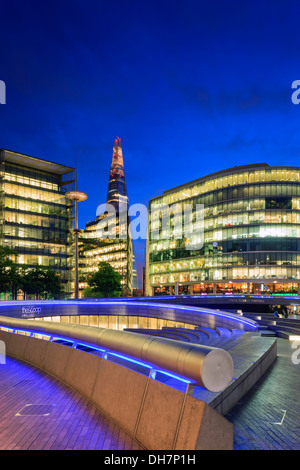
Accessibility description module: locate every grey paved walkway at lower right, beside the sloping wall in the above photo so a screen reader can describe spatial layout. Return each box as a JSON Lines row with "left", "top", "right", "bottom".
{"left": 226, "top": 338, "right": 300, "bottom": 450}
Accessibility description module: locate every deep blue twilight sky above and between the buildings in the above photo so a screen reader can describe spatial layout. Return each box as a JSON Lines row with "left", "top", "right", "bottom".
{"left": 0, "top": 0, "right": 300, "bottom": 284}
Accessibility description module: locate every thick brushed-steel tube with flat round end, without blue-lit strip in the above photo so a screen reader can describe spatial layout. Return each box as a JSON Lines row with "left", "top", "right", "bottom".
{"left": 0, "top": 316, "right": 234, "bottom": 392}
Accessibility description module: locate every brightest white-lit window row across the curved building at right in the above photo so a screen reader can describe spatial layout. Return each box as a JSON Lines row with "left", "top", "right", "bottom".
{"left": 149, "top": 224, "right": 300, "bottom": 252}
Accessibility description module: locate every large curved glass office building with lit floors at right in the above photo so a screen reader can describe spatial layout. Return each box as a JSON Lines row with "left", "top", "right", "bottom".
{"left": 146, "top": 163, "right": 300, "bottom": 295}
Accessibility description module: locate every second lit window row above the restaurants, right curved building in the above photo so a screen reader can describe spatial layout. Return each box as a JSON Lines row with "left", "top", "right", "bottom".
{"left": 150, "top": 252, "right": 300, "bottom": 274}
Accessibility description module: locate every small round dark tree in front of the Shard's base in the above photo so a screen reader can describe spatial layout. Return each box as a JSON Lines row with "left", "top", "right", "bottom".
{"left": 87, "top": 262, "right": 122, "bottom": 297}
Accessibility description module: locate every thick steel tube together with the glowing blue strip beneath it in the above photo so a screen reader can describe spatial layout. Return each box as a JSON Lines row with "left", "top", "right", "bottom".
{"left": 0, "top": 317, "right": 234, "bottom": 392}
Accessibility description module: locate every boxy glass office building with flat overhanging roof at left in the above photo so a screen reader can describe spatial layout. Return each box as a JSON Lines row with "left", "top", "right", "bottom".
{"left": 0, "top": 149, "right": 74, "bottom": 295}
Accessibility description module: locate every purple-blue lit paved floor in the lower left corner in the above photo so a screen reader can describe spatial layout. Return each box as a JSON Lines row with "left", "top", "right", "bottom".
{"left": 0, "top": 357, "right": 142, "bottom": 450}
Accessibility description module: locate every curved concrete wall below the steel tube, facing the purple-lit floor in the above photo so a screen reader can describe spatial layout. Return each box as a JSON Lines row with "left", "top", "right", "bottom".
{"left": 0, "top": 318, "right": 233, "bottom": 450}
